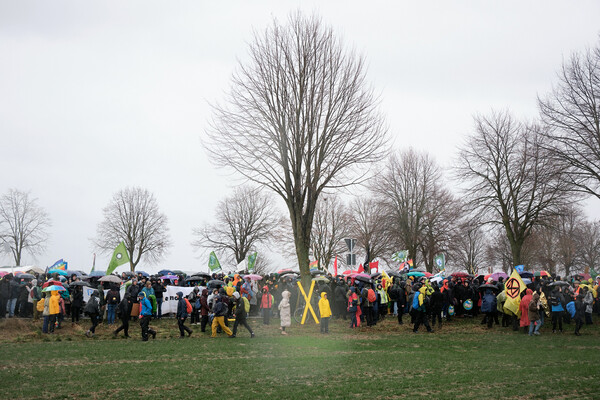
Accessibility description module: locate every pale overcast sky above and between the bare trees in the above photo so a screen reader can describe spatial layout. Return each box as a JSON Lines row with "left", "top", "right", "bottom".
{"left": 0, "top": 0, "right": 600, "bottom": 270}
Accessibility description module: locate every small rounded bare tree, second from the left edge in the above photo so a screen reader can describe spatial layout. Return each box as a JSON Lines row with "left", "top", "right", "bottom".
{"left": 95, "top": 187, "right": 171, "bottom": 271}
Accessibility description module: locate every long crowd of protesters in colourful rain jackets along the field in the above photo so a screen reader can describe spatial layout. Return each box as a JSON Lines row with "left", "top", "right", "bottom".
{"left": 0, "top": 273, "right": 600, "bottom": 341}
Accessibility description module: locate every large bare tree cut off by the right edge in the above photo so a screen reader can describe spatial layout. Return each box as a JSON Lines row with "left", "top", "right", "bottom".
{"left": 538, "top": 41, "right": 600, "bottom": 199}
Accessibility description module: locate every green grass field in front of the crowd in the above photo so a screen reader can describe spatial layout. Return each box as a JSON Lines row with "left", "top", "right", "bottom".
{"left": 0, "top": 319, "right": 600, "bottom": 400}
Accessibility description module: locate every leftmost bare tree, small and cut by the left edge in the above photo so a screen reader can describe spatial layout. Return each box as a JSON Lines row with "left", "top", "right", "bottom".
{"left": 0, "top": 189, "right": 50, "bottom": 267}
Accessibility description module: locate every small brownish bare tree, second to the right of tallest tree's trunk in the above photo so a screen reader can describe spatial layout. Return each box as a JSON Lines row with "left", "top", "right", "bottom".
{"left": 350, "top": 196, "right": 393, "bottom": 268}
